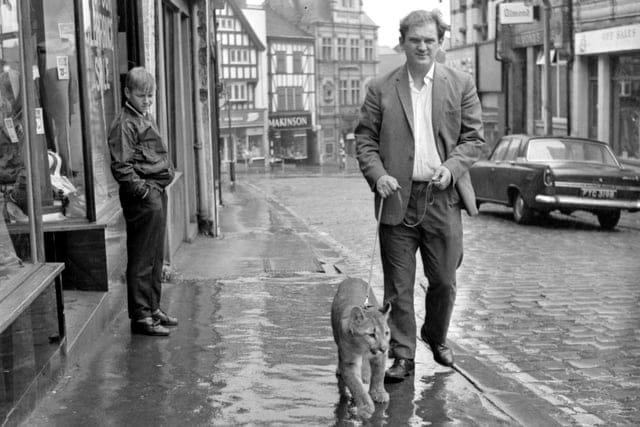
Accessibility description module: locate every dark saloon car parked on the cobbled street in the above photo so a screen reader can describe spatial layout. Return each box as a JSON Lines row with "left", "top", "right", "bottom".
{"left": 470, "top": 135, "right": 640, "bottom": 229}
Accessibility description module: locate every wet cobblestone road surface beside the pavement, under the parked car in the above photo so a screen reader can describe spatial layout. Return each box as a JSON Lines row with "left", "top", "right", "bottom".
{"left": 238, "top": 170, "right": 640, "bottom": 425}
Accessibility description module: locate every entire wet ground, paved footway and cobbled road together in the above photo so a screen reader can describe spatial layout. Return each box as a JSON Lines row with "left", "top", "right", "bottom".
{"left": 20, "top": 166, "right": 640, "bottom": 426}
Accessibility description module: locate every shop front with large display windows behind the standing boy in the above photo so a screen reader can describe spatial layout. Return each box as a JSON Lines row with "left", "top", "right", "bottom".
{"left": 0, "top": 0, "right": 217, "bottom": 423}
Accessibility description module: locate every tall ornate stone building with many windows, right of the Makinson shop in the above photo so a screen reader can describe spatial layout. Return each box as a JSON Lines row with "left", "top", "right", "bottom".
{"left": 265, "top": 0, "right": 378, "bottom": 166}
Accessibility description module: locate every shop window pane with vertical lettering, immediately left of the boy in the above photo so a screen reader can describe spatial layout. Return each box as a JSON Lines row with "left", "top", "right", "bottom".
{"left": 82, "top": 0, "right": 118, "bottom": 216}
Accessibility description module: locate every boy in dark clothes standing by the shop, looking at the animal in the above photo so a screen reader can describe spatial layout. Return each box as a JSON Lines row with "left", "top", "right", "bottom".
{"left": 109, "top": 67, "right": 178, "bottom": 336}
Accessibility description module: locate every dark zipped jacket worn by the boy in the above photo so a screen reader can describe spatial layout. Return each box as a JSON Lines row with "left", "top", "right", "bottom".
{"left": 109, "top": 103, "right": 174, "bottom": 198}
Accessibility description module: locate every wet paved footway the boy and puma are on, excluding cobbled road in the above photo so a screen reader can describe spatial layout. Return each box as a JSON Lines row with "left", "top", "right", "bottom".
{"left": 24, "top": 174, "right": 518, "bottom": 426}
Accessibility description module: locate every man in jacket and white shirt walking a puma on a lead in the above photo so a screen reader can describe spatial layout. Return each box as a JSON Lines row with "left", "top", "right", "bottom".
{"left": 355, "top": 10, "right": 485, "bottom": 381}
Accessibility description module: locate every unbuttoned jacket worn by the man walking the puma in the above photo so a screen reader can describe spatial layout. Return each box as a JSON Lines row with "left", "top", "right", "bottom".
{"left": 355, "top": 63, "right": 485, "bottom": 225}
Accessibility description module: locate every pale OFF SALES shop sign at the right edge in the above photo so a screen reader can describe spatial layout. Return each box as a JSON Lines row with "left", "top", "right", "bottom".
{"left": 575, "top": 24, "right": 640, "bottom": 55}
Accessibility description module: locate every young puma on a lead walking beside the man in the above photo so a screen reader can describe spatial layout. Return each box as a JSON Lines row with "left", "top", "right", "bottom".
{"left": 331, "top": 278, "right": 391, "bottom": 418}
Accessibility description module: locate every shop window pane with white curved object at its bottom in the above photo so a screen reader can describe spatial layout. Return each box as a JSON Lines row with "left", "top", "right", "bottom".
{"left": 31, "top": 0, "right": 87, "bottom": 222}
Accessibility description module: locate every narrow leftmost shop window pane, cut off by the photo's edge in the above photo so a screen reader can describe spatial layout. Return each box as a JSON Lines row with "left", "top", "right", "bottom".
{"left": 0, "top": 0, "right": 31, "bottom": 280}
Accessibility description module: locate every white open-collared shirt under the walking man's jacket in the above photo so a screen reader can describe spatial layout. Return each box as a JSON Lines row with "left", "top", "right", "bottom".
{"left": 409, "top": 65, "right": 442, "bottom": 181}
